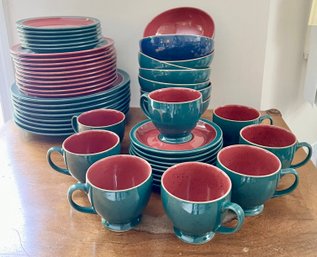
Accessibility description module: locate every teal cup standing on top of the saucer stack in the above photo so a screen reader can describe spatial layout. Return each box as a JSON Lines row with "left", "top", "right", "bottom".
{"left": 140, "top": 88, "right": 202, "bottom": 143}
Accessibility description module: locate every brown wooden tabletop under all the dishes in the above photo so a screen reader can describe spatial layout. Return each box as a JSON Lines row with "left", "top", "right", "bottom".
{"left": 0, "top": 106, "right": 317, "bottom": 257}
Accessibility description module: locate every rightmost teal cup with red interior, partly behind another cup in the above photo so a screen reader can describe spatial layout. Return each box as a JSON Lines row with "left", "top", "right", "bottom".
{"left": 240, "top": 124, "right": 312, "bottom": 168}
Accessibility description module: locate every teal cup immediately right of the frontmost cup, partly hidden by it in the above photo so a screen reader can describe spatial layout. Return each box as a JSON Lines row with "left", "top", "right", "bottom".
{"left": 217, "top": 145, "right": 298, "bottom": 216}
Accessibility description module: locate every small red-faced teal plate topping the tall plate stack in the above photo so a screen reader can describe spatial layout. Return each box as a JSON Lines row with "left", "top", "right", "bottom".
{"left": 17, "top": 16, "right": 99, "bottom": 30}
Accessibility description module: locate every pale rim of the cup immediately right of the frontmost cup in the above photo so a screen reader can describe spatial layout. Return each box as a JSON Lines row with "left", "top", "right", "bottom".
{"left": 217, "top": 144, "right": 282, "bottom": 178}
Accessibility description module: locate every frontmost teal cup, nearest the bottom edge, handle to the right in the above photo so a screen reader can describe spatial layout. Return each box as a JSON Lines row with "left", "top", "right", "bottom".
{"left": 161, "top": 162, "right": 244, "bottom": 244}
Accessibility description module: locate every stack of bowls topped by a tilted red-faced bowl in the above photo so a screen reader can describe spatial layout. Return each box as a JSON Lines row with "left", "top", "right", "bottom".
{"left": 138, "top": 7, "right": 215, "bottom": 113}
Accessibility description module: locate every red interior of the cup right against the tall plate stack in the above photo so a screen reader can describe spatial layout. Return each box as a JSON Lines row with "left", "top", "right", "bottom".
{"left": 78, "top": 109, "right": 125, "bottom": 127}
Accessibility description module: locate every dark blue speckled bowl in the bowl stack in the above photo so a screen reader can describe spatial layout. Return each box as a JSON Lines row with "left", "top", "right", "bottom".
{"left": 140, "top": 35, "right": 214, "bottom": 61}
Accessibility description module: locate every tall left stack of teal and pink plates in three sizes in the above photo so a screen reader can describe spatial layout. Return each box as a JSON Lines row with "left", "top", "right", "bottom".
{"left": 11, "top": 16, "right": 130, "bottom": 136}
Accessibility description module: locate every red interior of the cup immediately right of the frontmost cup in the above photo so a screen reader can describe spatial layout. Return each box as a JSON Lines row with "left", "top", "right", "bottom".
{"left": 218, "top": 145, "right": 281, "bottom": 176}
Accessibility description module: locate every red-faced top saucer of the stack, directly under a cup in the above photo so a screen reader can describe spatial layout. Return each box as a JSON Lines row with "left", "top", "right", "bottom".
{"left": 135, "top": 120, "right": 217, "bottom": 151}
